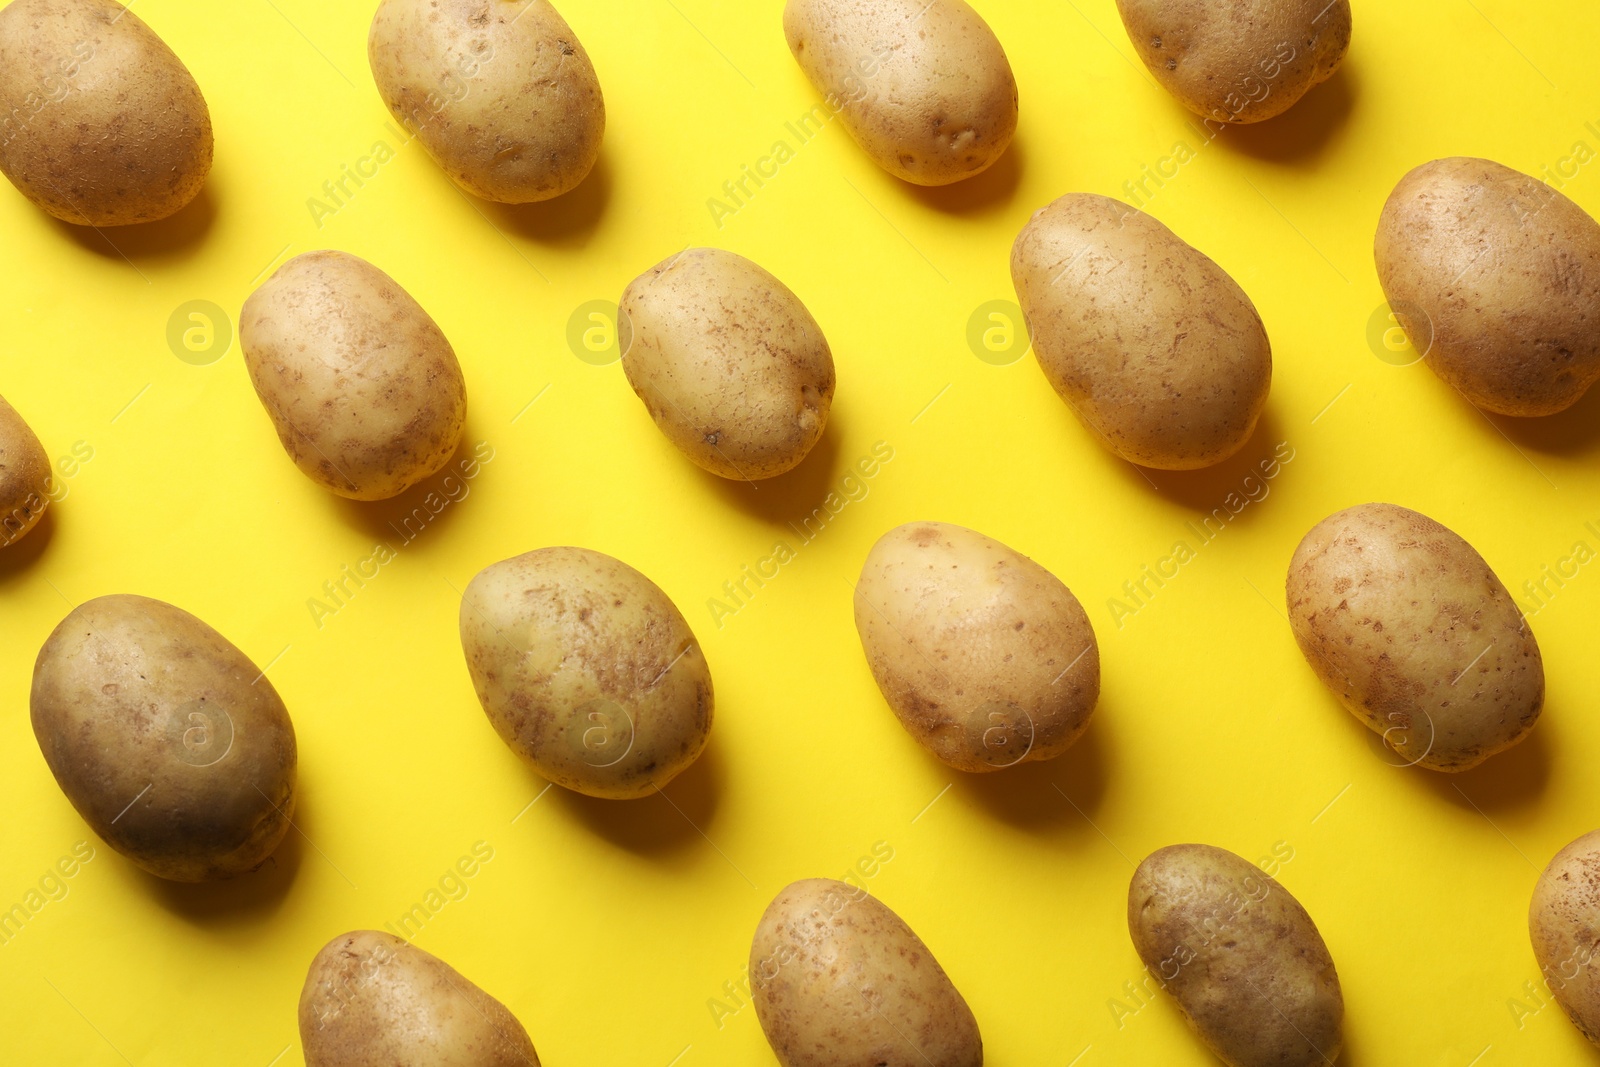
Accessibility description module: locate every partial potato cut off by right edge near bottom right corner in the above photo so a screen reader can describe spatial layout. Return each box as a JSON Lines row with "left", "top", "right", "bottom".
{"left": 1528, "top": 830, "right": 1600, "bottom": 1045}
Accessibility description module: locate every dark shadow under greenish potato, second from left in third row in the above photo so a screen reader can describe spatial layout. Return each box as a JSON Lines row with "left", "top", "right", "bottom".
{"left": 552, "top": 733, "right": 726, "bottom": 856}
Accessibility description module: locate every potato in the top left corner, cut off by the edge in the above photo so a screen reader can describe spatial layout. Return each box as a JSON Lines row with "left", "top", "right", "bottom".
{"left": 0, "top": 0, "right": 211, "bottom": 226}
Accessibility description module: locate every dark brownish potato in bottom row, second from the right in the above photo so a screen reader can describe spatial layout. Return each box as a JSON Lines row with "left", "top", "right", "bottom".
{"left": 1128, "top": 845, "right": 1344, "bottom": 1067}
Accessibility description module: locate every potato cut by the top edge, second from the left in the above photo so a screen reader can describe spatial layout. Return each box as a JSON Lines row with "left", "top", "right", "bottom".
{"left": 366, "top": 0, "right": 605, "bottom": 203}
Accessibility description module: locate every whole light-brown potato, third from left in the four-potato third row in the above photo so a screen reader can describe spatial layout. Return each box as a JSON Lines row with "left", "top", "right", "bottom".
{"left": 856, "top": 523, "right": 1099, "bottom": 771}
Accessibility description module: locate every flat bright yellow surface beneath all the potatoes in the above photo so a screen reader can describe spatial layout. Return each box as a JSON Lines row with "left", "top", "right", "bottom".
{"left": 0, "top": 0, "right": 1600, "bottom": 1067}
